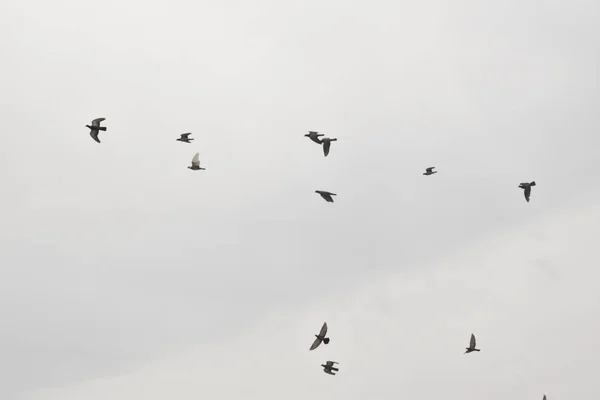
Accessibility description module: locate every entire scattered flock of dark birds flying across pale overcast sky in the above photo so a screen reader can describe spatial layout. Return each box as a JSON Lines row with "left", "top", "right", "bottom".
{"left": 86, "top": 118, "right": 546, "bottom": 400}
